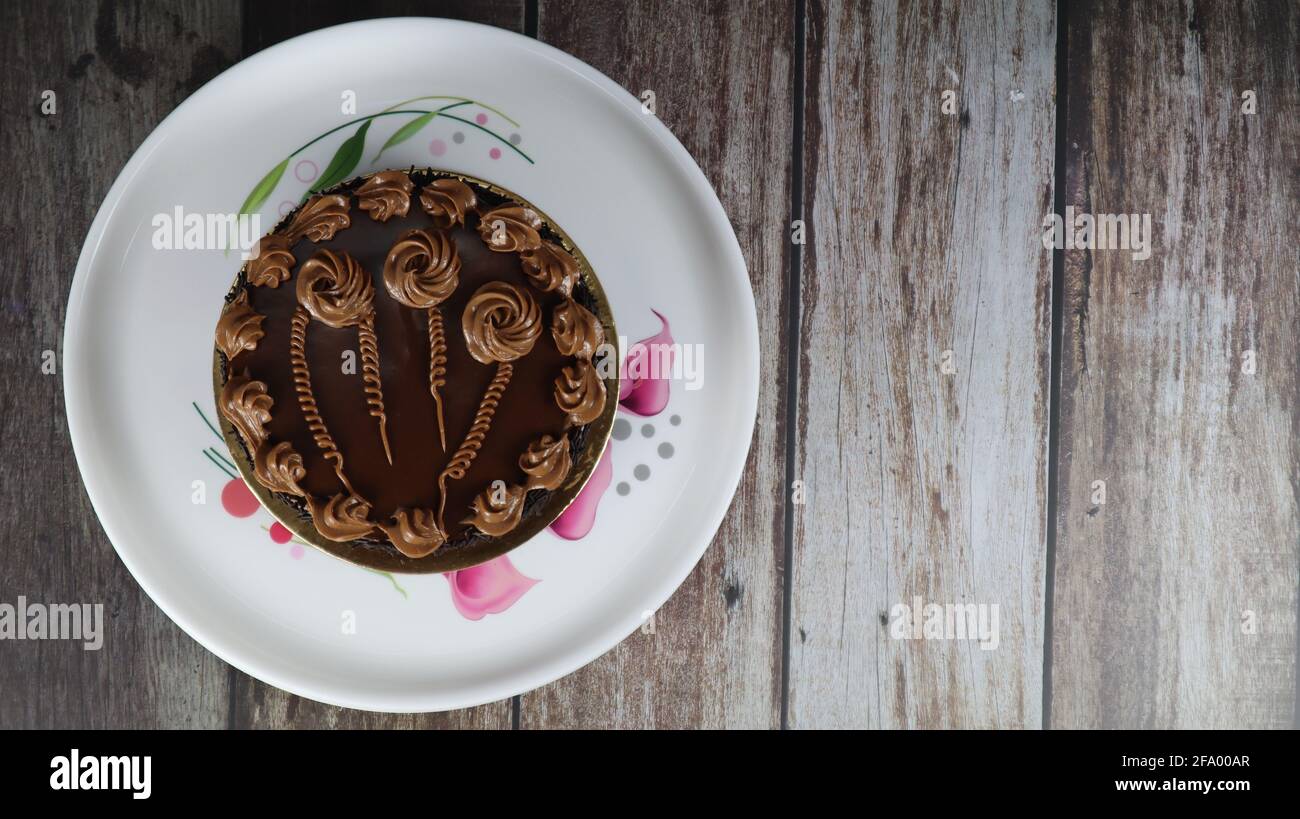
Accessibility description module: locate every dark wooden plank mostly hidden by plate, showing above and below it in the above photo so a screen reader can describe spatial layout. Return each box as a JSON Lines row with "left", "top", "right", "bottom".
{"left": 230, "top": 0, "right": 524, "bottom": 729}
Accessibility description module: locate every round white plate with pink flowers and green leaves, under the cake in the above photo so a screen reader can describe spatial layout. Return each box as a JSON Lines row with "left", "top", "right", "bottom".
{"left": 64, "top": 18, "right": 759, "bottom": 711}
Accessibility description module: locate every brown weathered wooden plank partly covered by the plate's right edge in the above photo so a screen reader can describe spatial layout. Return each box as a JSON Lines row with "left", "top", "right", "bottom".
{"left": 520, "top": 0, "right": 793, "bottom": 728}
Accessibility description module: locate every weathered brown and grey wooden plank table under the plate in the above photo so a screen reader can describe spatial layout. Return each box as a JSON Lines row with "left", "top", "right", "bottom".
{"left": 0, "top": 0, "right": 1300, "bottom": 728}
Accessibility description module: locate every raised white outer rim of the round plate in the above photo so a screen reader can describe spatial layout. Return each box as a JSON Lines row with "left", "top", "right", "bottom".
{"left": 61, "top": 17, "right": 761, "bottom": 714}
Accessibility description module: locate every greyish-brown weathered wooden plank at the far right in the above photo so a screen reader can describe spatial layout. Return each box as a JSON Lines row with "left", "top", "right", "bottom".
{"left": 1052, "top": 3, "right": 1300, "bottom": 728}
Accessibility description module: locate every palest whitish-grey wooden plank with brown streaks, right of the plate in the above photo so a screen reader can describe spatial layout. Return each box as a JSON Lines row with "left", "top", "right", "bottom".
{"left": 789, "top": 0, "right": 1056, "bottom": 728}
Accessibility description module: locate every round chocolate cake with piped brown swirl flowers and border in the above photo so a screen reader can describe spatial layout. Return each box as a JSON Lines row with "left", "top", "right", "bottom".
{"left": 215, "top": 169, "right": 618, "bottom": 571}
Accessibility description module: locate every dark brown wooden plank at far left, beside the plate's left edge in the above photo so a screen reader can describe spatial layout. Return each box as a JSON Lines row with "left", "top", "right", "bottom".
{"left": 0, "top": 0, "right": 239, "bottom": 728}
